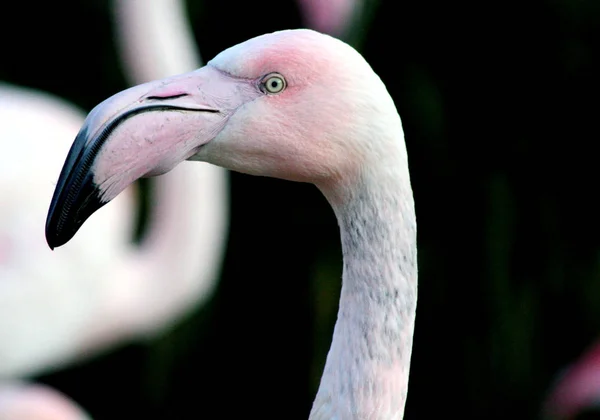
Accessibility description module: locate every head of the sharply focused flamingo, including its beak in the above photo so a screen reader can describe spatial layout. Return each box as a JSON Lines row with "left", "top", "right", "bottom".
{"left": 46, "top": 30, "right": 405, "bottom": 248}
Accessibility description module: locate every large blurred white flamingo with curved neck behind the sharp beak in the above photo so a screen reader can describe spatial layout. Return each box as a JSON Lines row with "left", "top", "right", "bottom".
{"left": 0, "top": 0, "right": 228, "bottom": 419}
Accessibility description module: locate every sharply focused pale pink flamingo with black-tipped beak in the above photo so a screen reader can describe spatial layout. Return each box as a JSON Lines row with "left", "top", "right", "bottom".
{"left": 46, "top": 29, "right": 417, "bottom": 420}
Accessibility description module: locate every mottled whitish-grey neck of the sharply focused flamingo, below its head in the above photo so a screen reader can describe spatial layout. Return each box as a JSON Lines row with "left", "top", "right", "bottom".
{"left": 310, "top": 166, "right": 417, "bottom": 420}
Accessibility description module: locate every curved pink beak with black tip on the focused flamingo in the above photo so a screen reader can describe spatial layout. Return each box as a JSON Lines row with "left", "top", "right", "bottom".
{"left": 46, "top": 66, "right": 260, "bottom": 249}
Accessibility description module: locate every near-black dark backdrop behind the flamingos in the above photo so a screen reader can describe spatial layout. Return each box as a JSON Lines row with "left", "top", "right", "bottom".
{"left": 0, "top": 0, "right": 600, "bottom": 420}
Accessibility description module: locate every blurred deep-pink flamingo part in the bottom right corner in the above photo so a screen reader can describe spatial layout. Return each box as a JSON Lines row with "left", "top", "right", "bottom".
{"left": 543, "top": 341, "right": 600, "bottom": 420}
